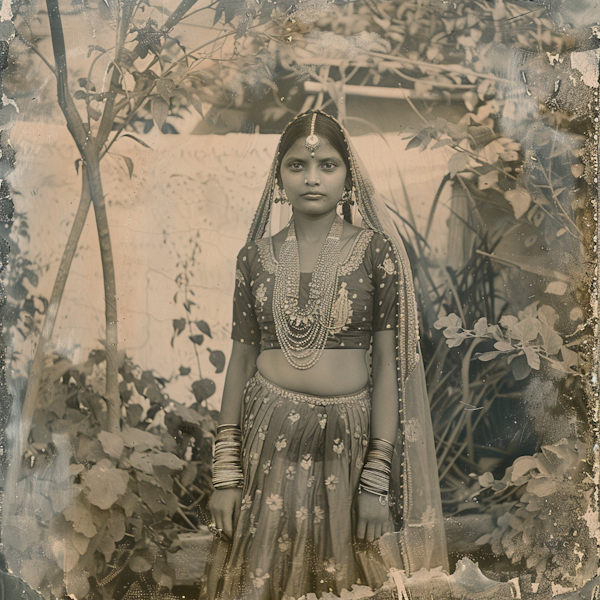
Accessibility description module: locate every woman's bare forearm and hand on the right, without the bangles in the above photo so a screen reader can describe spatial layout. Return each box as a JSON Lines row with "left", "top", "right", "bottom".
{"left": 356, "top": 329, "right": 399, "bottom": 541}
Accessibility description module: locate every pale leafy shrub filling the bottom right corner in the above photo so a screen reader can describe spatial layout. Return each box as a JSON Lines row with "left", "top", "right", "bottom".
{"left": 477, "top": 439, "right": 596, "bottom": 586}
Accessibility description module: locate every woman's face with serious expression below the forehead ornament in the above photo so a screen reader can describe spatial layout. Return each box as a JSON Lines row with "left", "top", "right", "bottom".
{"left": 280, "top": 136, "right": 348, "bottom": 217}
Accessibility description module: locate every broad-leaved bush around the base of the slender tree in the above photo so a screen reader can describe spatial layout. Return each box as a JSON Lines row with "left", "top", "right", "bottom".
{"left": 5, "top": 351, "right": 216, "bottom": 599}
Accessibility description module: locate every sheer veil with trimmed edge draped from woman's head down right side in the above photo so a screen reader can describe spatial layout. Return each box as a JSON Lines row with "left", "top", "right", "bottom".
{"left": 248, "top": 111, "right": 448, "bottom": 574}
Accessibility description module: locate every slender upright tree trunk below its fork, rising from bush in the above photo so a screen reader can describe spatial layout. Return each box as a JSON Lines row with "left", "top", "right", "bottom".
{"left": 87, "top": 148, "right": 121, "bottom": 433}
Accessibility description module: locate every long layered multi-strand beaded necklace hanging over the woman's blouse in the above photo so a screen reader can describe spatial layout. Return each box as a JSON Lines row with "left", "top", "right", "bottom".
{"left": 273, "top": 215, "right": 344, "bottom": 370}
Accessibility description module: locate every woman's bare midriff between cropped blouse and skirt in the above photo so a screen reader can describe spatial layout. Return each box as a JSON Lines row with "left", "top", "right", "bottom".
{"left": 256, "top": 349, "right": 369, "bottom": 396}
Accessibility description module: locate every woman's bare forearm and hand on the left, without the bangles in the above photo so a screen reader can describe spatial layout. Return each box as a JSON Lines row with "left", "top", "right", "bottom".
{"left": 208, "top": 340, "right": 260, "bottom": 540}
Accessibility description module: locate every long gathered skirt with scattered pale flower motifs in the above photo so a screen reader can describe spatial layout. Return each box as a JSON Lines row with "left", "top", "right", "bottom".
{"left": 205, "top": 373, "right": 402, "bottom": 600}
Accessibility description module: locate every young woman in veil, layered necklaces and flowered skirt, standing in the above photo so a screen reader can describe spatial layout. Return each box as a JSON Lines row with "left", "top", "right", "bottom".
{"left": 206, "top": 111, "right": 447, "bottom": 600}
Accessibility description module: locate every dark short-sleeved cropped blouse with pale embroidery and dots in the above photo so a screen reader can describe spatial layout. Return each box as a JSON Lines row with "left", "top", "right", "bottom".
{"left": 231, "top": 229, "right": 398, "bottom": 350}
